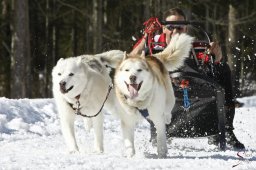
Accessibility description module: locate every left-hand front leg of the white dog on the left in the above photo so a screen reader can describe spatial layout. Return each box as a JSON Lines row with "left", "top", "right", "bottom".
{"left": 60, "top": 113, "right": 78, "bottom": 153}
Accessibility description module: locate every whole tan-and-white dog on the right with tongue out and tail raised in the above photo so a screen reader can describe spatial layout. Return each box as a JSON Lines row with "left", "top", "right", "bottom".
{"left": 114, "top": 34, "right": 193, "bottom": 158}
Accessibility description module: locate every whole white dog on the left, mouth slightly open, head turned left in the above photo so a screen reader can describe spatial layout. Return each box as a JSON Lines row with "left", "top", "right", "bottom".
{"left": 52, "top": 50, "right": 124, "bottom": 153}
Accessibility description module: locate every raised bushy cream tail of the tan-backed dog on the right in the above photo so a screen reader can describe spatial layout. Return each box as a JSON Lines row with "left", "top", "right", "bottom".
{"left": 154, "top": 33, "right": 194, "bottom": 71}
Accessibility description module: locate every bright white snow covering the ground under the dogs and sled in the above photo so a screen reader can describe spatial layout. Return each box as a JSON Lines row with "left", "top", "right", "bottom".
{"left": 0, "top": 96, "right": 256, "bottom": 170}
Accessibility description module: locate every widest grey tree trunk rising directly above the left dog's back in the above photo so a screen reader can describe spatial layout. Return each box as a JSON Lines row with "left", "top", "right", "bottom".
{"left": 92, "top": 0, "right": 103, "bottom": 53}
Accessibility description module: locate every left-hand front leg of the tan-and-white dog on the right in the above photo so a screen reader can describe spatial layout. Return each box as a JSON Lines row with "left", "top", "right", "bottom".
{"left": 121, "top": 120, "right": 135, "bottom": 158}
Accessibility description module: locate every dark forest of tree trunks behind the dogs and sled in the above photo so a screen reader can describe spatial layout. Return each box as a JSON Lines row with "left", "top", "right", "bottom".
{"left": 0, "top": 0, "right": 256, "bottom": 98}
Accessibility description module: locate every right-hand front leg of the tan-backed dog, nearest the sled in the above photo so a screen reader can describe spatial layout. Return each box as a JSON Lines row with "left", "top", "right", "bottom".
{"left": 153, "top": 116, "right": 167, "bottom": 158}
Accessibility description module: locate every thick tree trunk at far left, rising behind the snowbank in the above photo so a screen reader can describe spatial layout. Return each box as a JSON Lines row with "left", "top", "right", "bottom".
{"left": 11, "top": 0, "right": 32, "bottom": 98}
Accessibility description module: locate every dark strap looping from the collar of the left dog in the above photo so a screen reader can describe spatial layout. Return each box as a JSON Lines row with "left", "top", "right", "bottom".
{"left": 69, "top": 84, "right": 113, "bottom": 118}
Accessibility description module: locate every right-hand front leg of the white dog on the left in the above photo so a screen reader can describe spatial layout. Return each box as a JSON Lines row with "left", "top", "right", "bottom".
{"left": 92, "top": 113, "right": 104, "bottom": 153}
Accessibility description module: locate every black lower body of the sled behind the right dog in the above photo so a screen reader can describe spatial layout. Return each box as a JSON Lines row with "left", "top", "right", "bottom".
{"left": 166, "top": 72, "right": 226, "bottom": 150}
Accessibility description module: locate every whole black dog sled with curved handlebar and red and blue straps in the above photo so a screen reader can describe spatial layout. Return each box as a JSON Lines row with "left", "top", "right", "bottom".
{"left": 141, "top": 18, "right": 226, "bottom": 150}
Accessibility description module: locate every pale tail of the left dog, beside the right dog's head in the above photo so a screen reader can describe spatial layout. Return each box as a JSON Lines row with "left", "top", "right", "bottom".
{"left": 95, "top": 50, "right": 124, "bottom": 68}
